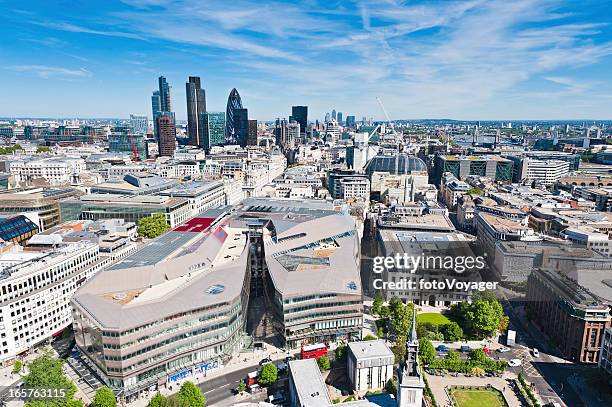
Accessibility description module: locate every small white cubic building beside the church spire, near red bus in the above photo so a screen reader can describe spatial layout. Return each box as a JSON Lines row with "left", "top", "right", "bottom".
{"left": 347, "top": 340, "right": 395, "bottom": 391}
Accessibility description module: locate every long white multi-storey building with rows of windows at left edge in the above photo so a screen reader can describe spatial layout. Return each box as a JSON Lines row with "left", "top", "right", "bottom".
{"left": 0, "top": 239, "right": 111, "bottom": 366}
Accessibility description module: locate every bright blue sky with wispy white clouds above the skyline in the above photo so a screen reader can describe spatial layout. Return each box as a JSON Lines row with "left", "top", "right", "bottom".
{"left": 0, "top": 0, "right": 612, "bottom": 120}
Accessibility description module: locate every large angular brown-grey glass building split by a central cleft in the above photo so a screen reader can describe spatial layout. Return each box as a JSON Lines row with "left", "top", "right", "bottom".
{"left": 72, "top": 199, "right": 363, "bottom": 399}
